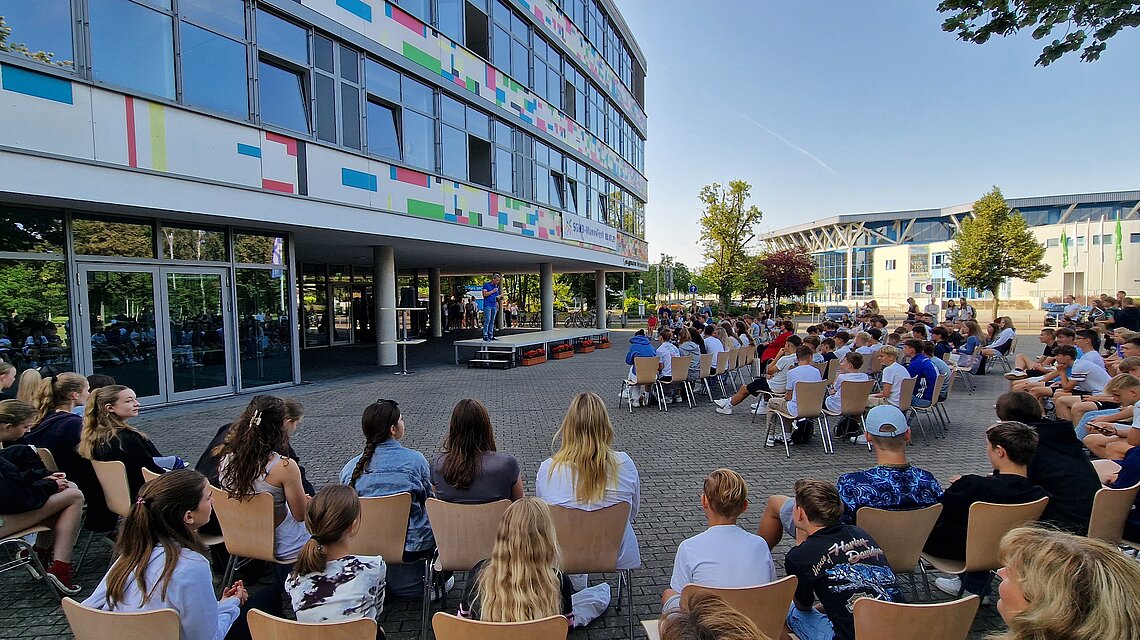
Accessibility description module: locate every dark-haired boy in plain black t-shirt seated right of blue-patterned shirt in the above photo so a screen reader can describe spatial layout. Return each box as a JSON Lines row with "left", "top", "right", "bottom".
{"left": 922, "top": 421, "right": 1049, "bottom": 598}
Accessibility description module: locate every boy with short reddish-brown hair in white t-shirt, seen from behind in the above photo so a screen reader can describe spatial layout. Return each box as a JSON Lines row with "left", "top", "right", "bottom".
{"left": 661, "top": 469, "right": 776, "bottom": 614}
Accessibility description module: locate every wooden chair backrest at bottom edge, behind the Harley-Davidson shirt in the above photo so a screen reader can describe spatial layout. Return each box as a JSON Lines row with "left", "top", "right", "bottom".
{"left": 855, "top": 596, "right": 982, "bottom": 640}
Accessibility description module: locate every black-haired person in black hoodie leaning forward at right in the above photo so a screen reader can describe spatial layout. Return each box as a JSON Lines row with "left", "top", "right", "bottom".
{"left": 996, "top": 391, "right": 1100, "bottom": 535}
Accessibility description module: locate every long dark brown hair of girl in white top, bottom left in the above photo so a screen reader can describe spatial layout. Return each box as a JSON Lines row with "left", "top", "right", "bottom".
{"left": 106, "top": 469, "right": 207, "bottom": 608}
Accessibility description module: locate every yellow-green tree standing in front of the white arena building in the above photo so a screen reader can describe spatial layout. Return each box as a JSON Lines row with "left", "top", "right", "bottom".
{"left": 950, "top": 187, "right": 1051, "bottom": 318}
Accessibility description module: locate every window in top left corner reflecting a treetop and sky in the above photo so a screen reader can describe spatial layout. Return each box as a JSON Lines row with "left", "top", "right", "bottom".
{"left": 2, "top": 0, "right": 75, "bottom": 68}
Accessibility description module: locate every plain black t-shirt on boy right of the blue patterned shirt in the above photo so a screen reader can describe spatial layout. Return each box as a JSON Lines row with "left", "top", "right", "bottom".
{"left": 922, "top": 473, "right": 1049, "bottom": 560}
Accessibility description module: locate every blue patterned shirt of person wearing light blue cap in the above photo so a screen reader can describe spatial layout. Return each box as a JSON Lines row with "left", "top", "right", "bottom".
{"left": 836, "top": 464, "right": 942, "bottom": 525}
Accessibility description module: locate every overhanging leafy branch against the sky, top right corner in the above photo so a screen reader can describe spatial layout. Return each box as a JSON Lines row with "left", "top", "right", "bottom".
{"left": 938, "top": 0, "right": 1140, "bottom": 66}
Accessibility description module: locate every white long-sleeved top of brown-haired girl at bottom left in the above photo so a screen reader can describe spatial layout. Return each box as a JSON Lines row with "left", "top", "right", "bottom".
{"left": 83, "top": 545, "right": 239, "bottom": 640}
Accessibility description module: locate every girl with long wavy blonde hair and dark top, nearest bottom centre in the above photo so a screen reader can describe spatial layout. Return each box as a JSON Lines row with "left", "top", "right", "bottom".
{"left": 459, "top": 497, "right": 573, "bottom": 622}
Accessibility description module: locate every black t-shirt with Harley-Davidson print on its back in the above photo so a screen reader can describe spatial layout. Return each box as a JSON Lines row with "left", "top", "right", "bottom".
{"left": 784, "top": 525, "right": 903, "bottom": 640}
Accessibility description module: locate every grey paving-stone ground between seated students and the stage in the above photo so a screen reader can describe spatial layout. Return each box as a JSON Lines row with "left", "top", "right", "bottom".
{"left": 0, "top": 331, "right": 1035, "bottom": 640}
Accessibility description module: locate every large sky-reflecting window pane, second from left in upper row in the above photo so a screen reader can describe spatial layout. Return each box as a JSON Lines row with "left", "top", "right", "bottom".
{"left": 90, "top": 0, "right": 174, "bottom": 99}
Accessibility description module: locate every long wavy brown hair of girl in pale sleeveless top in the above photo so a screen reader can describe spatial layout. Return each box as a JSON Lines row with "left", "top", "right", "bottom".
{"left": 213, "top": 396, "right": 288, "bottom": 500}
